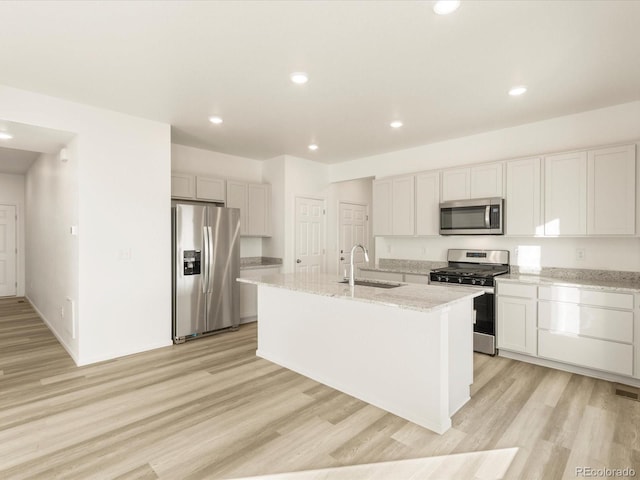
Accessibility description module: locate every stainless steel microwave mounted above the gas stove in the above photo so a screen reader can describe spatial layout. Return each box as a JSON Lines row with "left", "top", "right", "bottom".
{"left": 440, "top": 198, "right": 504, "bottom": 235}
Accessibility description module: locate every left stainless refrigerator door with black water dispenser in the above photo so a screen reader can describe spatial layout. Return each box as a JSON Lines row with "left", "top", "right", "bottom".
{"left": 173, "top": 204, "right": 208, "bottom": 341}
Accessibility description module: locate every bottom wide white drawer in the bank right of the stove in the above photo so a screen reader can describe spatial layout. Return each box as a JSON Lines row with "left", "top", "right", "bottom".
{"left": 538, "top": 330, "right": 633, "bottom": 376}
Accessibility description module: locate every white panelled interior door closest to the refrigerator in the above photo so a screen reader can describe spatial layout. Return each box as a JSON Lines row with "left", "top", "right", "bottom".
{"left": 295, "top": 197, "right": 326, "bottom": 272}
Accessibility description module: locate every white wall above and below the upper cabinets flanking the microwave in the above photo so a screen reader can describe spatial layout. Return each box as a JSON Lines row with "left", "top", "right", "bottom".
{"left": 329, "top": 102, "right": 640, "bottom": 271}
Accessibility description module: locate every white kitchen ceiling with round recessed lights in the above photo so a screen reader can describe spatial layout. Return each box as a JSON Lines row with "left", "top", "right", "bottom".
{"left": 0, "top": 0, "right": 640, "bottom": 163}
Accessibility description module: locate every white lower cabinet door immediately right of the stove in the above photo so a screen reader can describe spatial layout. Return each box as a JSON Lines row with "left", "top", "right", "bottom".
{"left": 496, "top": 295, "right": 537, "bottom": 355}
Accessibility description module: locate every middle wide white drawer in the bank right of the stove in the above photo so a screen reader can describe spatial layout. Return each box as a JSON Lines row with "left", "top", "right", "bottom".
{"left": 538, "top": 301, "right": 633, "bottom": 343}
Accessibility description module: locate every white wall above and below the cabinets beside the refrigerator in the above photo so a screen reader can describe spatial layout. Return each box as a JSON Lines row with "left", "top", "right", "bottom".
{"left": 171, "top": 143, "right": 269, "bottom": 257}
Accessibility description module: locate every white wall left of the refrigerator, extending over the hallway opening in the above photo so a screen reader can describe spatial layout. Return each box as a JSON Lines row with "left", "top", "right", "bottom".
{"left": 0, "top": 86, "right": 171, "bottom": 364}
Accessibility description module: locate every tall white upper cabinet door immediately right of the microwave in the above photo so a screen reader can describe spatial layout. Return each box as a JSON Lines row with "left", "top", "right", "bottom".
{"left": 505, "top": 158, "right": 544, "bottom": 236}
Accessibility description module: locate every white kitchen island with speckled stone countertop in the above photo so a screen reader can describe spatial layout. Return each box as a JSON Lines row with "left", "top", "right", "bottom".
{"left": 238, "top": 274, "right": 482, "bottom": 433}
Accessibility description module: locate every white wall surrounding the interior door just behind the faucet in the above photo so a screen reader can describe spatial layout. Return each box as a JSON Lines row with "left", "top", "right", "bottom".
{"left": 327, "top": 178, "right": 375, "bottom": 273}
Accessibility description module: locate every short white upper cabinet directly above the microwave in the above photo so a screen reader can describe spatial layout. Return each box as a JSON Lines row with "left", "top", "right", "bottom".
{"left": 442, "top": 163, "right": 504, "bottom": 202}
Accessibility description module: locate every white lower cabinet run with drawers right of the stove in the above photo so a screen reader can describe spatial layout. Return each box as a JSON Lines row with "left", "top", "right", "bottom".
{"left": 496, "top": 281, "right": 640, "bottom": 378}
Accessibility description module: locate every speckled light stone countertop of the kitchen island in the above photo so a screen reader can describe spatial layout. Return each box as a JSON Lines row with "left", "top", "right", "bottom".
{"left": 238, "top": 273, "right": 484, "bottom": 312}
